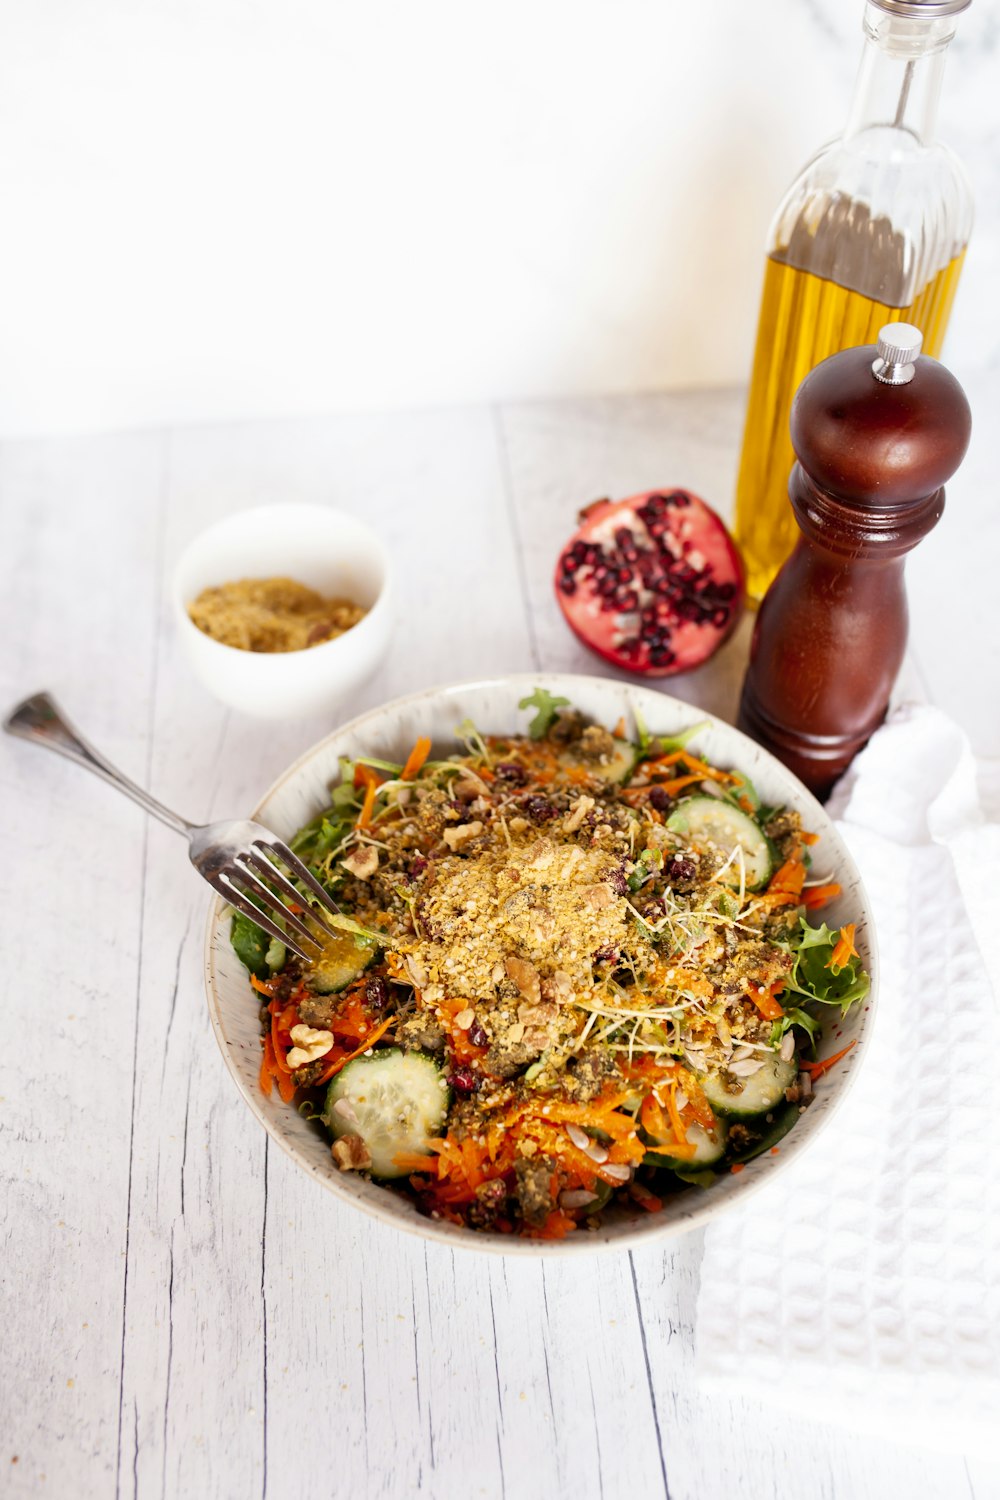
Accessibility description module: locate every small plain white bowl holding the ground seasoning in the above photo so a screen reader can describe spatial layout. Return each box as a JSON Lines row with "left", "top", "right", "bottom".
{"left": 174, "top": 504, "right": 393, "bottom": 719}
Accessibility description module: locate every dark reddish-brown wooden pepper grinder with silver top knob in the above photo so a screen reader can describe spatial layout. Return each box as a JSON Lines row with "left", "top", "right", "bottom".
{"left": 739, "top": 323, "right": 972, "bottom": 797}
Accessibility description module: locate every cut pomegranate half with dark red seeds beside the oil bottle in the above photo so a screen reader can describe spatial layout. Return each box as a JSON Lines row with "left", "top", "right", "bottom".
{"left": 555, "top": 489, "right": 744, "bottom": 677}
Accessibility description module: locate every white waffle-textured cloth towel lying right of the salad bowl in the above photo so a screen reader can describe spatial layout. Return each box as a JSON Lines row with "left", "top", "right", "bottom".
{"left": 697, "top": 707, "right": 1000, "bottom": 1457}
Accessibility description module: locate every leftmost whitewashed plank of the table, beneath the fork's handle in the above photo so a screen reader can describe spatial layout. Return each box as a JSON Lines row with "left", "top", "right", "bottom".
{"left": 0, "top": 435, "right": 163, "bottom": 1497}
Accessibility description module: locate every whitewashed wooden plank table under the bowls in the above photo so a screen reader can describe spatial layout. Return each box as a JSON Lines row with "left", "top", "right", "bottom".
{"left": 0, "top": 378, "right": 1000, "bottom": 1500}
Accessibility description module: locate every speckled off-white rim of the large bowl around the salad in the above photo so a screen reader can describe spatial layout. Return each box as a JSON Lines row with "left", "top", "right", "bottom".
{"left": 205, "top": 672, "right": 877, "bottom": 1256}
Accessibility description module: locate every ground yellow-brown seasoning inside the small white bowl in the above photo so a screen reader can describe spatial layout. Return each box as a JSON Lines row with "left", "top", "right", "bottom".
{"left": 187, "top": 578, "right": 367, "bottom": 651}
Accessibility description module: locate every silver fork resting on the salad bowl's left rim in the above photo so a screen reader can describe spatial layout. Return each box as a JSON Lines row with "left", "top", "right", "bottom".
{"left": 3, "top": 693, "right": 340, "bottom": 960}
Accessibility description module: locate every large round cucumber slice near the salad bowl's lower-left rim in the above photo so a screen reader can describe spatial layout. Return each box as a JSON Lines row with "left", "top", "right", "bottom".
{"left": 321, "top": 1047, "right": 451, "bottom": 1178}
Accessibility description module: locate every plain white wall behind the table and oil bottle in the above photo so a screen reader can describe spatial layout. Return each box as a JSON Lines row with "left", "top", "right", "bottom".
{"left": 0, "top": 0, "right": 1000, "bottom": 435}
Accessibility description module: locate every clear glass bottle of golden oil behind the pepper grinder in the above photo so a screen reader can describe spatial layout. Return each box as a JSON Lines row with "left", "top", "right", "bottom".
{"left": 735, "top": 0, "right": 972, "bottom": 599}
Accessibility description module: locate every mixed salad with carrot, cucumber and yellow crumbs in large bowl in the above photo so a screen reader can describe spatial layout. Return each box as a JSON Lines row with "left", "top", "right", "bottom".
{"left": 231, "top": 690, "right": 868, "bottom": 1239}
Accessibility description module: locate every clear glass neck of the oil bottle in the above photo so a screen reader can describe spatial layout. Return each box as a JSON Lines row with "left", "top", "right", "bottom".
{"left": 844, "top": 3, "right": 957, "bottom": 146}
